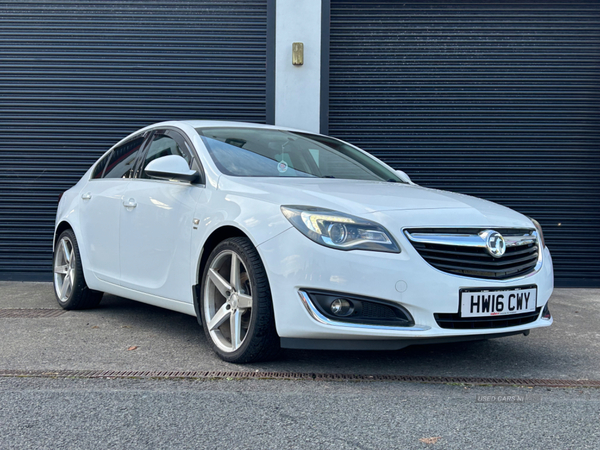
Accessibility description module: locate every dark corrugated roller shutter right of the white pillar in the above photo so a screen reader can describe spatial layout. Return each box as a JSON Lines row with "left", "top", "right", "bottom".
{"left": 328, "top": 0, "right": 600, "bottom": 286}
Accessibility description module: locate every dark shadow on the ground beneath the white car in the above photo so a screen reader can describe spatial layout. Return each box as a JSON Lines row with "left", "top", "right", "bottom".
{"left": 82, "top": 295, "right": 570, "bottom": 378}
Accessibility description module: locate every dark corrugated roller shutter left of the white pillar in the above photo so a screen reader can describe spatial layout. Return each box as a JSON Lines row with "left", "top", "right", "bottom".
{"left": 0, "top": 0, "right": 267, "bottom": 279}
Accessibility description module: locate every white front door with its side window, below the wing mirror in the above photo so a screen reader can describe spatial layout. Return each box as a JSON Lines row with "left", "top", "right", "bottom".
{"left": 120, "top": 130, "right": 206, "bottom": 302}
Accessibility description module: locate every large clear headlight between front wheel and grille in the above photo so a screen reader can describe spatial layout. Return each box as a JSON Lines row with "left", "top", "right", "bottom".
{"left": 281, "top": 206, "right": 400, "bottom": 253}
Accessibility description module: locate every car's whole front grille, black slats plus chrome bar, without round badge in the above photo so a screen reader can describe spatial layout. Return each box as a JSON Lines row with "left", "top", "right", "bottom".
{"left": 404, "top": 227, "right": 541, "bottom": 280}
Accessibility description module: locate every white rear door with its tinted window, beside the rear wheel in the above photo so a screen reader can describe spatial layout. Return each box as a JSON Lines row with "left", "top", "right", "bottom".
{"left": 79, "top": 135, "right": 145, "bottom": 284}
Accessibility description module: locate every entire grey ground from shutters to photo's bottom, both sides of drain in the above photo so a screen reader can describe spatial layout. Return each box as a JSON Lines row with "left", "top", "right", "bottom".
{"left": 0, "top": 282, "right": 600, "bottom": 450}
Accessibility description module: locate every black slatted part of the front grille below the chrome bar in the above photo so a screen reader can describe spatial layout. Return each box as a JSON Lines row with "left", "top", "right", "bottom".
{"left": 407, "top": 229, "right": 539, "bottom": 280}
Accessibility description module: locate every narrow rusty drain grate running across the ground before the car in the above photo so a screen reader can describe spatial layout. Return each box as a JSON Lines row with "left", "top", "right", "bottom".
{"left": 0, "top": 370, "right": 600, "bottom": 388}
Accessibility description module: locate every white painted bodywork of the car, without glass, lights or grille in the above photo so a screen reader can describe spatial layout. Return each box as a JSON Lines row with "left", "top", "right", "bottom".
{"left": 56, "top": 121, "right": 553, "bottom": 339}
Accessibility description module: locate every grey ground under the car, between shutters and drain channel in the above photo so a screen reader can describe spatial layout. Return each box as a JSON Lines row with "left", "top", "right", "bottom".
{"left": 0, "top": 282, "right": 600, "bottom": 380}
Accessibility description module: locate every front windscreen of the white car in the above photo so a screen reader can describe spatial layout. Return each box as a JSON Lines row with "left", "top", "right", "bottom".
{"left": 196, "top": 128, "right": 402, "bottom": 182}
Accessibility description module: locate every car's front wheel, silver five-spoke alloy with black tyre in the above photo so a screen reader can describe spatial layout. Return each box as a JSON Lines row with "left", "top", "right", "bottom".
{"left": 201, "top": 237, "right": 280, "bottom": 363}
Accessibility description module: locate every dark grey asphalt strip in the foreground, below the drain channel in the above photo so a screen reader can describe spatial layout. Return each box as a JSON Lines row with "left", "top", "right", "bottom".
{"left": 0, "top": 378, "right": 600, "bottom": 450}
